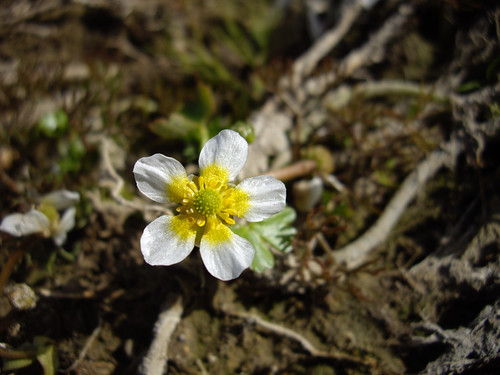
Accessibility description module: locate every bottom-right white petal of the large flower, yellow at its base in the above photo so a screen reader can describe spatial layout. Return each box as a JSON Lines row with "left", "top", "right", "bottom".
{"left": 200, "top": 224, "right": 255, "bottom": 281}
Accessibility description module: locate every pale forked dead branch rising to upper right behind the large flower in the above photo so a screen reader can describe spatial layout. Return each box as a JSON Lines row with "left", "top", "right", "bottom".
{"left": 242, "top": 4, "right": 414, "bottom": 177}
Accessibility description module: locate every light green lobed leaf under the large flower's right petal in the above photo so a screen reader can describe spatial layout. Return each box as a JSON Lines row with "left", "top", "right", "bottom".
{"left": 233, "top": 207, "right": 297, "bottom": 273}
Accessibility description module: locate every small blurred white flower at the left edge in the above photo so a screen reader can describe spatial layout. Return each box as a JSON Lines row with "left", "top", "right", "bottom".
{"left": 0, "top": 190, "right": 80, "bottom": 246}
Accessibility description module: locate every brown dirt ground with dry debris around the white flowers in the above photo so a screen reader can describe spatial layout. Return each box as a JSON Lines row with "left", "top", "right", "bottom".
{"left": 0, "top": 0, "right": 500, "bottom": 375}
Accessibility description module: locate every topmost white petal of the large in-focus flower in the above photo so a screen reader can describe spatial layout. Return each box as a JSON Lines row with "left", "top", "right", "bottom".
{"left": 199, "top": 129, "right": 248, "bottom": 182}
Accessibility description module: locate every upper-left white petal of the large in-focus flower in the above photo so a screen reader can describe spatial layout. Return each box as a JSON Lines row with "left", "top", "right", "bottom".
{"left": 134, "top": 154, "right": 188, "bottom": 203}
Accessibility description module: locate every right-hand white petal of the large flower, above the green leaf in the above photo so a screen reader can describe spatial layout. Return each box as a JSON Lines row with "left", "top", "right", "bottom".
{"left": 236, "top": 176, "right": 286, "bottom": 222}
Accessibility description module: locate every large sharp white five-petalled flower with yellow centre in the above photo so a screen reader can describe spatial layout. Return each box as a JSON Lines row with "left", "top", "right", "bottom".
{"left": 134, "top": 130, "right": 286, "bottom": 280}
